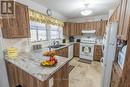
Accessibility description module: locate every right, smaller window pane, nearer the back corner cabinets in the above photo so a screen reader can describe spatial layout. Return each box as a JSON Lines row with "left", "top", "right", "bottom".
{"left": 50, "top": 25, "right": 62, "bottom": 39}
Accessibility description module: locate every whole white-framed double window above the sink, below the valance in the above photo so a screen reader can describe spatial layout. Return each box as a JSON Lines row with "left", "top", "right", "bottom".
{"left": 30, "top": 21, "right": 63, "bottom": 42}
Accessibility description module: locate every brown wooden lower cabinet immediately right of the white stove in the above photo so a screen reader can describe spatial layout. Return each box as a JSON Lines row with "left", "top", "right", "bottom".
{"left": 94, "top": 45, "right": 103, "bottom": 61}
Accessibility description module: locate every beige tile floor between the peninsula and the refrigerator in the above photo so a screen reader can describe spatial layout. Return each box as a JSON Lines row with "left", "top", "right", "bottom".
{"left": 69, "top": 57, "right": 101, "bottom": 87}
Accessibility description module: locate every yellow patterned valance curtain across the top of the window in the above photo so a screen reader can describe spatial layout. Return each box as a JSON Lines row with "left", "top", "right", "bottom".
{"left": 29, "top": 9, "right": 64, "bottom": 27}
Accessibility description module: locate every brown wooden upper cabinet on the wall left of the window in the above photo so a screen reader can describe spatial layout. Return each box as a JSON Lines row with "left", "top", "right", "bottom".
{"left": 2, "top": 2, "right": 30, "bottom": 39}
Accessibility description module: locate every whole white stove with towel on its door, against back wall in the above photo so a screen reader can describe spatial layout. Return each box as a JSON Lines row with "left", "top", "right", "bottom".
{"left": 80, "top": 38, "right": 96, "bottom": 61}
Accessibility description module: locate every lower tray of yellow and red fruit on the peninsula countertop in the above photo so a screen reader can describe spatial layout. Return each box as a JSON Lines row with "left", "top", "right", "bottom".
{"left": 41, "top": 57, "right": 57, "bottom": 67}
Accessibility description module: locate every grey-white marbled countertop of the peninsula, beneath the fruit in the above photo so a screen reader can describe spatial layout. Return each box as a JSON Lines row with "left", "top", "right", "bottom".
{"left": 5, "top": 50, "right": 70, "bottom": 81}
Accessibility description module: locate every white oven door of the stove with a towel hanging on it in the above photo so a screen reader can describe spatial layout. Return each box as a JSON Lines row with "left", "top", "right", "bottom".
{"left": 80, "top": 43, "right": 94, "bottom": 60}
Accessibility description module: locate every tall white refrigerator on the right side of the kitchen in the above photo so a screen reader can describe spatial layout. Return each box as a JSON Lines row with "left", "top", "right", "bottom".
{"left": 101, "top": 22, "right": 118, "bottom": 87}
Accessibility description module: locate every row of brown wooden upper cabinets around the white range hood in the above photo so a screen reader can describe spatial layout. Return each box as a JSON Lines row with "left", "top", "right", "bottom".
{"left": 63, "top": 20, "right": 107, "bottom": 36}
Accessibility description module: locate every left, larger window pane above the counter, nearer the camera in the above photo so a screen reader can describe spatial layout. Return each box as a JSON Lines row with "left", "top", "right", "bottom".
{"left": 30, "top": 22, "right": 47, "bottom": 42}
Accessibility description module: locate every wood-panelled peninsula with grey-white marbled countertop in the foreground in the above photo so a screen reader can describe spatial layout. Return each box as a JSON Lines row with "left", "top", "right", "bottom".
{"left": 5, "top": 50, "right": 70, "bottom": 87}
